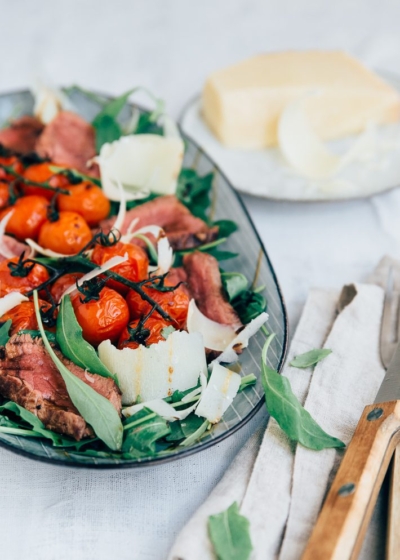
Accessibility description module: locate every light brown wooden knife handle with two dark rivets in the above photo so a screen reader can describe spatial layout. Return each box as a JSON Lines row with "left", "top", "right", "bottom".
{"left": 302, "top": 401, "right": 400, "bottom": 560}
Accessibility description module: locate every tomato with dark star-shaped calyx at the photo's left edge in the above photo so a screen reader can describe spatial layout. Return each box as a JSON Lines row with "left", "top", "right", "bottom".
{"left": 0, "top": 257, "right": 49, "bottom": 297}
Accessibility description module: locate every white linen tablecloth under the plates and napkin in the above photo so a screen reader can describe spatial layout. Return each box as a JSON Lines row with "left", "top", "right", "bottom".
{"left": 0, "top": 0, "right": 400, "bottom": 560}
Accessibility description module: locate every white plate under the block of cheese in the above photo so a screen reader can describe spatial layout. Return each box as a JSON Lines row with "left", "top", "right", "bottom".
{"left": 180, "top": 72, "right": 400, "bottom": 201}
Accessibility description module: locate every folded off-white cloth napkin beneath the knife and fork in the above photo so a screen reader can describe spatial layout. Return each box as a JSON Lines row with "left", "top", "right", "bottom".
{"left": 168, "top": 258, "right": 391, "bottom": 560}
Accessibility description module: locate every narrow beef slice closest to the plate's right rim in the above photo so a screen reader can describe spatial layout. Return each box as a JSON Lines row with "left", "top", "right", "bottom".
{"left": 183, "top": 251, "right": 242, "bottom": 329}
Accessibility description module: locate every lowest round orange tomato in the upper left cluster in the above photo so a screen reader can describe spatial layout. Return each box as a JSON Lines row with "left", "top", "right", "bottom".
{"left": 39, "top": 212, "right": 92, "bottom": 255}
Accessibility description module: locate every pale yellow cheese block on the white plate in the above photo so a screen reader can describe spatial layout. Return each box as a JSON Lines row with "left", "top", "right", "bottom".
{"left": 203, "top": 51, "right": 400, "bottom": 149}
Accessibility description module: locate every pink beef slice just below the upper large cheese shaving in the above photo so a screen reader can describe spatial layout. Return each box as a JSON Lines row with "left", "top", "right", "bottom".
{"left": 100, "top": 195, "right": 218, "bottom": 250}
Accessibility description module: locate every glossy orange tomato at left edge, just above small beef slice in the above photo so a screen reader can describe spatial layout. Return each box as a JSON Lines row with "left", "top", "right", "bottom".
{"left": 0, "top": 195, "right": 49, "bottom": 241}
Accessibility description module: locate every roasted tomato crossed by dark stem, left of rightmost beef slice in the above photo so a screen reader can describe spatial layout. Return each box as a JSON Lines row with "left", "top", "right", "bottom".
{"left": 126, "top": 280, "right": 189, "bottom": 328}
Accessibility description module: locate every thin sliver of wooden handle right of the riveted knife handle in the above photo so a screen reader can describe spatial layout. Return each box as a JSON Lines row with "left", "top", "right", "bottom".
{"left": 386, "top": 445, "right": 400, "bottom": 560}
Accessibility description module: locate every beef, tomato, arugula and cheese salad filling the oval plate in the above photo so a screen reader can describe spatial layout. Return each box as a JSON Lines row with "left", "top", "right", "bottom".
{"left": 0, "top": 88, "right": 268, "bottom": 461}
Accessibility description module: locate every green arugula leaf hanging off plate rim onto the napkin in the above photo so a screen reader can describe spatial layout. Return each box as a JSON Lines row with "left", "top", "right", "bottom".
{"left": 261, "top": 334, "right": 345, "bottom": 451}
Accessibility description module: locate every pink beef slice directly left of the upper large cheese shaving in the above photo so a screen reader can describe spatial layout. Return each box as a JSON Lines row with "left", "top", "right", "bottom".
{"left": 36, "top": 111, "right": 98, "bottom": 175}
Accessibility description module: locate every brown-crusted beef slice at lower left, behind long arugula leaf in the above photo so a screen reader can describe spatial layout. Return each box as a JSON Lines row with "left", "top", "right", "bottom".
{"left": 0, "top": 335, "right": 121, "bottom": 441}
